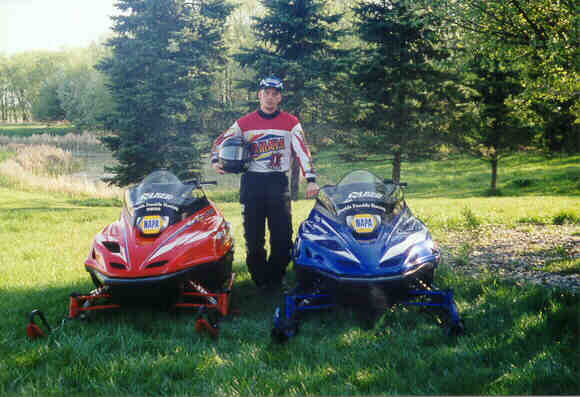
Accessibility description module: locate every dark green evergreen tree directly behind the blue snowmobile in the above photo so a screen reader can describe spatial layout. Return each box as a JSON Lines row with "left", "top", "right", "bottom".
{"left": 343, "top": 0, "right": 450, "bottom": 181}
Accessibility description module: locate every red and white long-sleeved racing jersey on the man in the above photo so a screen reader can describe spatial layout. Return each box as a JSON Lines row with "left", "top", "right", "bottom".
{"left": 211, "top": 110, "right": 316, "bottom": 182}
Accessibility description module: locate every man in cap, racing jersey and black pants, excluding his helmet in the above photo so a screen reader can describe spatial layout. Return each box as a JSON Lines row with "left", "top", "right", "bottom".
{"left": 211, "top": 77, "right": 319, "bottom": 289}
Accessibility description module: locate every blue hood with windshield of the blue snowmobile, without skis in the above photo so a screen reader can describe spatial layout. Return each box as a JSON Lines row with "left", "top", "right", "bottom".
{"left": 294, "top": 171, "right": 439, "bottom": 279}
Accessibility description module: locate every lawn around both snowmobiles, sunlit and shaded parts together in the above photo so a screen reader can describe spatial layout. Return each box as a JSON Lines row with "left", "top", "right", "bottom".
{"left": 0, "top": 184, "right": 580, "bottom": 396}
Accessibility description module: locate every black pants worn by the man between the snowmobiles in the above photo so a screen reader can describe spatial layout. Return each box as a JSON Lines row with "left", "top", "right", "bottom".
{"left": 240, "top": 172, "right": 292, "bottom": 286}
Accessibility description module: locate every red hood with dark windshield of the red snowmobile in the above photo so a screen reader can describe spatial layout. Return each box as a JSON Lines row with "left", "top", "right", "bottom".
{"left": 85, "top": 172, "right": 233, "bottom": 279}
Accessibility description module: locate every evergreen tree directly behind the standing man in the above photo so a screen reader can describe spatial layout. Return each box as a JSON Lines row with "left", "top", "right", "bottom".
{"left": 235, "top": 0, "right": 341, "bottom": 200}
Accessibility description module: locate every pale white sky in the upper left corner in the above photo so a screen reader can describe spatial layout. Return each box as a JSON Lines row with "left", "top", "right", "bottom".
{"left": 0, "top": 0, "right": 119, "bottom": 55}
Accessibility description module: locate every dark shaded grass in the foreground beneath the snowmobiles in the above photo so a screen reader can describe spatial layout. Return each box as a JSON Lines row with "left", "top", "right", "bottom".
{"left": 0, "top": 271, "right": 580, "bottom": 395}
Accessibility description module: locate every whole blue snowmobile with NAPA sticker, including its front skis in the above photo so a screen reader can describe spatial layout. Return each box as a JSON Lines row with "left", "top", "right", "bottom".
{"left": 272, "top": 170, "right": 464, "bottom": 342}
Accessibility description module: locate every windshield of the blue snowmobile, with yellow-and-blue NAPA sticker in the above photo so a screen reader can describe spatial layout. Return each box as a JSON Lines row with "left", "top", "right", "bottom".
{"left": 318, "top": 170, "right": 405, "bottom": 234}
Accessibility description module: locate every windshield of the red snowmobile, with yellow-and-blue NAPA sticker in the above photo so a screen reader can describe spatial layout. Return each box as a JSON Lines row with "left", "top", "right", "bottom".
{"left": 125, "top": 171, "right": 209, "bottom": 236}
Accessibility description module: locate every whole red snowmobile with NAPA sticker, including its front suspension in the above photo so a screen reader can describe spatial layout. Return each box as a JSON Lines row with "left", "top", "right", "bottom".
{"left": 69, "top": 171, "right": 235, "bottom": 336}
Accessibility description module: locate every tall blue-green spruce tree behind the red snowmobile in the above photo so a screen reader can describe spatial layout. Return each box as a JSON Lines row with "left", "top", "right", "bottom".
{"left": 98, "top": 0, "right": 232, "bottom": 186}
